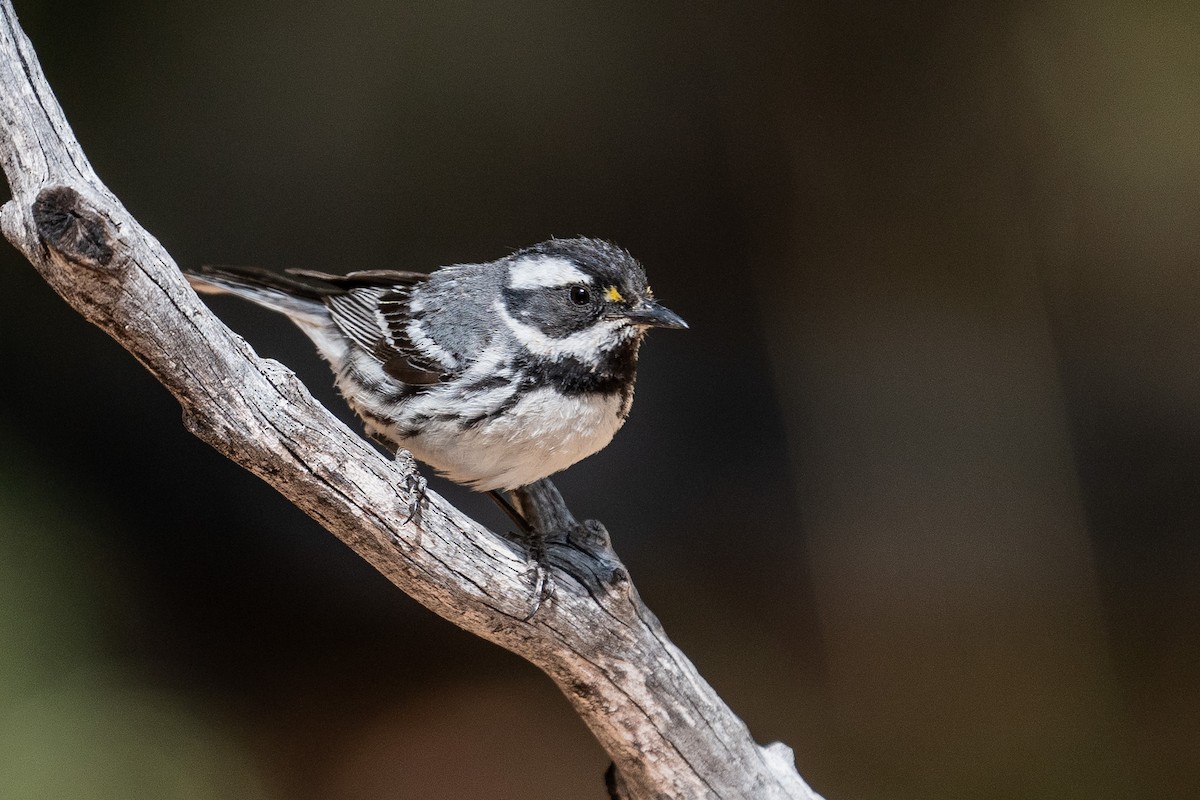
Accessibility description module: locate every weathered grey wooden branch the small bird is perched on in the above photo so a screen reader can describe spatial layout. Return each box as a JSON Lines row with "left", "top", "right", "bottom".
{"left": 0, "top": 0, "right": 817, "bottom": 800}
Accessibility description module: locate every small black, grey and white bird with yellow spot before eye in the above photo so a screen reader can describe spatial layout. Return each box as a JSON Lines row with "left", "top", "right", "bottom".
{"left": 187, "top": 239, "right": 688, "bottom": 506}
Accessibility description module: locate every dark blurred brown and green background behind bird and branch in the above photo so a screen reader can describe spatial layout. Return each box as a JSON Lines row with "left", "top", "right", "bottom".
{"left": 0, "top": 0, "right": 1200, "bottom": 800}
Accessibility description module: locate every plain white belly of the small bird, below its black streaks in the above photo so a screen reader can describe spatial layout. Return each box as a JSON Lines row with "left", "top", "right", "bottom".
{"left": 391, "top": 389, "right": 625, "bottom": 492}
